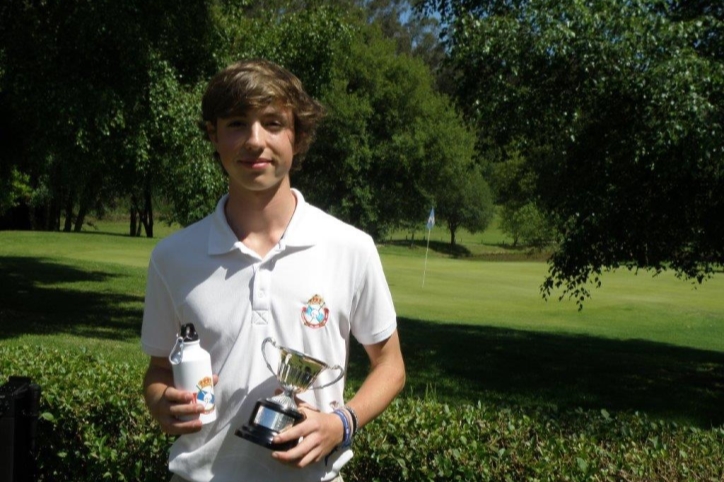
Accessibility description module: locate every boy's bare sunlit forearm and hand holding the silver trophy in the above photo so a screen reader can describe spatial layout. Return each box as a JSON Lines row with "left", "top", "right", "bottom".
{"left": 272, "top": 331, "right": 405, "bottom": 468}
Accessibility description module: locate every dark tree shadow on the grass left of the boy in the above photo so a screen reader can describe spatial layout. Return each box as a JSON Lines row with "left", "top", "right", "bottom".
{"left": 0, "top": 257, "right": 144, "bottom": 339}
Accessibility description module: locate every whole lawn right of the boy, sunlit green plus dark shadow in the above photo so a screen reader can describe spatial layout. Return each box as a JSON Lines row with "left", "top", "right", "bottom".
{"left": 359, "top": 249, "right": 724, "bottom": 426}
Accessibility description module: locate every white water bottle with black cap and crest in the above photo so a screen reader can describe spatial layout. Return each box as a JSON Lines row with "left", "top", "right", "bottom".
{"left": 168, "top": 323, "right": 216, "bottom": 424}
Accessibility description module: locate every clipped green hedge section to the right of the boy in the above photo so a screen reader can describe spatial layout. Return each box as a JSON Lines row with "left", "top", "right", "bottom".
{"left": 346, "top": 398, "right": 724, "bottom": 481}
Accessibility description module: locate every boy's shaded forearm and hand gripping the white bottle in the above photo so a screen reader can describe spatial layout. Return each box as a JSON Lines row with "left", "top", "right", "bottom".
{"left": 143, "top": 357, "right": 208, "bottom": 435}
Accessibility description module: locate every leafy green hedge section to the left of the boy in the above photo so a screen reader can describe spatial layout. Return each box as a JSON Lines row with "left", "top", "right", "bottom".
{"left": 0, "top": 346, "right": 172, "bottom": 482}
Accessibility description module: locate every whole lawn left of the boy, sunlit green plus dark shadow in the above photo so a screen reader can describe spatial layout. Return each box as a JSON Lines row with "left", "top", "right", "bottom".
{"left": 0, "top": 228, "right": 158, "bottom": 362}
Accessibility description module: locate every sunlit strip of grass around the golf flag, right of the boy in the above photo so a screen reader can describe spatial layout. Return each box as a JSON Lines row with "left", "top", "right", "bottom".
{"left": 383, "top": 255, "right": 724, "bottom": 351}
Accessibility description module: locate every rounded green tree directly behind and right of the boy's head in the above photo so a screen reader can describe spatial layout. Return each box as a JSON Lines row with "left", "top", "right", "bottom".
{"left": 224, "top": 2, "right": 474, "bottom": 239}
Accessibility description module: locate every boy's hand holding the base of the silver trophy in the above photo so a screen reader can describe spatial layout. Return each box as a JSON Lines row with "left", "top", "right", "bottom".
{"left": 272, "top": 403, "right": 344, "bottom": 468}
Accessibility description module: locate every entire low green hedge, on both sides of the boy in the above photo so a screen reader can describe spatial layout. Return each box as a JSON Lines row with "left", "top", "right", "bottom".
{"left": 0, "top": 346, "right": 724, "bottom": 482}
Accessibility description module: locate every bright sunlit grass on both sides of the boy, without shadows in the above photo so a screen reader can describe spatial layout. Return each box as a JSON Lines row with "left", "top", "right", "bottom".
{"left": 5, "top": 226, "right": 724, "bottom": 351}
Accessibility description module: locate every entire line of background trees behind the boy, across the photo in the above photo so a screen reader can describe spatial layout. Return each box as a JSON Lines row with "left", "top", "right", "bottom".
{"left": 0, "top": 0, "right": 724, "bottom": 300}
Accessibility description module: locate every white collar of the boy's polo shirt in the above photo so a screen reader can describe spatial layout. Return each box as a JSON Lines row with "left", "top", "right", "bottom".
{"left": 208, "top": 189, "right": 320, "bottom": 255}
